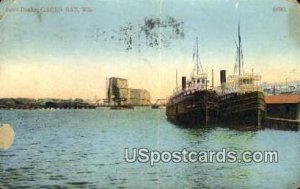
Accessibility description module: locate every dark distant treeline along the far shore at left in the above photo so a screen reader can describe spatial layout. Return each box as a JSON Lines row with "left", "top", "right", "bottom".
{"left": 0, "top": 98, "right": 96, "bottom": 109}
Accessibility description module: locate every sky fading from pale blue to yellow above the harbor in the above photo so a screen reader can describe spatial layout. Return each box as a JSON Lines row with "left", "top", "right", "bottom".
{"left": 0, "top": 0, "right": 300, "bottom": 99}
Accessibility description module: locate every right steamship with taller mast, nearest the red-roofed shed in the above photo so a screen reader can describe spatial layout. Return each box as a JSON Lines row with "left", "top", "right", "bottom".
{"left": 219, "top": 24, "right": 265, "bottom": 128}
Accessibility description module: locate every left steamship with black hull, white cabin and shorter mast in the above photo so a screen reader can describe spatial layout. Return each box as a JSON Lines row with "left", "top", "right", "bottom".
{"left": 166, "top": 38, "right": 218, "bottom": 127}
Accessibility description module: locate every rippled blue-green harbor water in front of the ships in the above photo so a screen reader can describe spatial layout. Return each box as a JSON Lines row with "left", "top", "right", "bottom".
{"left": 0, "top": 108, "right": 300, "bottom": 188}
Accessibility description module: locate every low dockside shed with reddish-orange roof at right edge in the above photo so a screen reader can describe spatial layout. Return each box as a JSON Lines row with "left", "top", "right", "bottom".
{"left": 265, "top": 94, "right": 300, "bottom": 120}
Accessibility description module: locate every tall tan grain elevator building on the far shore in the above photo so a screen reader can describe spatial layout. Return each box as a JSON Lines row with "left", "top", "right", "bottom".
{"left": 107, "top": 77, "right": 151, "bottom": 106}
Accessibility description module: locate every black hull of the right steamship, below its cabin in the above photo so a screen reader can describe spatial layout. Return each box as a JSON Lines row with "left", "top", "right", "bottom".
{"left": 219, "top": 91, "right": 265, "bottom": 129}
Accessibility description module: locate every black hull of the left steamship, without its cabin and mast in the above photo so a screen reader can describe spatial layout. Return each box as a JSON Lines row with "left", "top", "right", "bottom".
{"left": 166, "top": 90, "right": 218, "bottom": 127}
